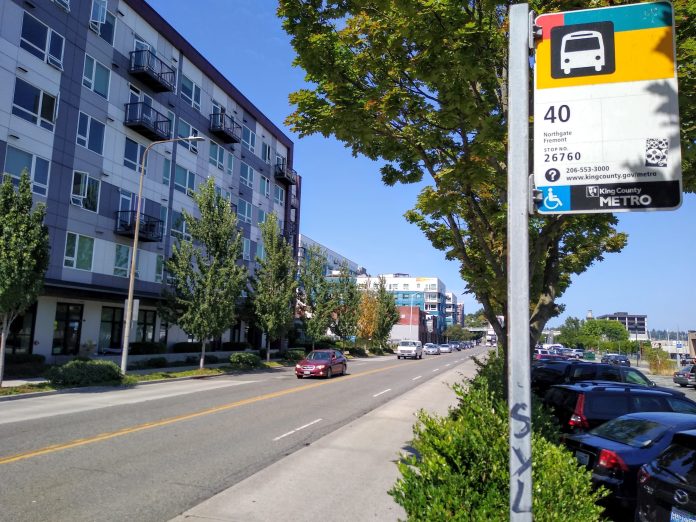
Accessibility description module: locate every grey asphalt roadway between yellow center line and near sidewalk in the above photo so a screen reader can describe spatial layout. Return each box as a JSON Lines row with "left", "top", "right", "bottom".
{"left": 0, "top": 348, "right": 482, "bottom": 520}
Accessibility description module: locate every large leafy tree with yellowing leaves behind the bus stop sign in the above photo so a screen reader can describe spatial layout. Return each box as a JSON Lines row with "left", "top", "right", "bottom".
{"left": 278, "top": 0, "right": 696, "bottom": 348}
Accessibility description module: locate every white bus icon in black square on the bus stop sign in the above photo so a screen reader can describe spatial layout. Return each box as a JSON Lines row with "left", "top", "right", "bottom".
{"left": 551, "top": 22, "right": 616, "bottom": 79}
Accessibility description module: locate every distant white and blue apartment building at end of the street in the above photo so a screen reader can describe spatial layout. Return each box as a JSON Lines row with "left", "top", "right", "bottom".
{"left": 357, "top": 273, "right": 447, "bottom": 342}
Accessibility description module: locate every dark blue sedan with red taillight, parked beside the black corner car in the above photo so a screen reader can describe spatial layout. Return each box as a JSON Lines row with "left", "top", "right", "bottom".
{"left": 564, "top": 412, "right": 696, "bottom": 514}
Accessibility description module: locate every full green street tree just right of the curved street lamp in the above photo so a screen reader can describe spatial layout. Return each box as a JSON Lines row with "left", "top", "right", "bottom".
{"left": 163, "top": 178, "right": 247, "bottom": 368}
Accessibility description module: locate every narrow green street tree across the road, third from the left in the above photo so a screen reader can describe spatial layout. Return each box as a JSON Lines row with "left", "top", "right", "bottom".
{"left": 251, "top": 214, "right": 297, "bottom": 361}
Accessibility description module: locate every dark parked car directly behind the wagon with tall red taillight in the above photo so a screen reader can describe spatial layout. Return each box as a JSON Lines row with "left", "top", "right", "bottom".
{"left": 531, "top": 360, "right": 655, "bottom": 397}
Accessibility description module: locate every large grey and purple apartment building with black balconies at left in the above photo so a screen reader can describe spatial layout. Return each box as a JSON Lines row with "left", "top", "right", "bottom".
{"left": 0, "top": 0, "right": 302, "bottom": 356}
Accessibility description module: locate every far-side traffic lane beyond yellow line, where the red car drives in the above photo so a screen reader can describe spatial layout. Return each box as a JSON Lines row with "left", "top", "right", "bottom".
{"left": 0, "top": 357, "right": 402, "bottom": 458}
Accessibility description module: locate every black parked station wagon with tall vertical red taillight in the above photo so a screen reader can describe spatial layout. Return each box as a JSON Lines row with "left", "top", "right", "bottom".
{"left": 544, "top": 382, "right": 696, "bottom": 433}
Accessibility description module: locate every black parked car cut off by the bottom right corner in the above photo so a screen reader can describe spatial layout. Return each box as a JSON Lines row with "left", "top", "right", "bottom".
{"left": 636, "top": 430, "right": 696, "bottom": 522}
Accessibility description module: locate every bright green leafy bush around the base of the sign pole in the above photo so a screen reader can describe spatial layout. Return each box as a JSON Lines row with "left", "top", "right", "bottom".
{"left": 389, "top": 352, "right": 604, "bottom": 522}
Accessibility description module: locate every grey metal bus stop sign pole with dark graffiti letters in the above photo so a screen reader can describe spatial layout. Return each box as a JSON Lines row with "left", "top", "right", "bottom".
{"left": 507, "top": 4, "right": 532, "bottom": 522}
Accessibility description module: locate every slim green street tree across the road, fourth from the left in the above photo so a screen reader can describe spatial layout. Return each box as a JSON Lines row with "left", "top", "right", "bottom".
{"left": 299, "top": 245, "right": 332, "bottom": 348}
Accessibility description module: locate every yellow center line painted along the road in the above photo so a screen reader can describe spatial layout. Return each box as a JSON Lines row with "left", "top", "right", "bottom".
{"left": 0, "top": 364, "right": 403, "bottom": 465}
